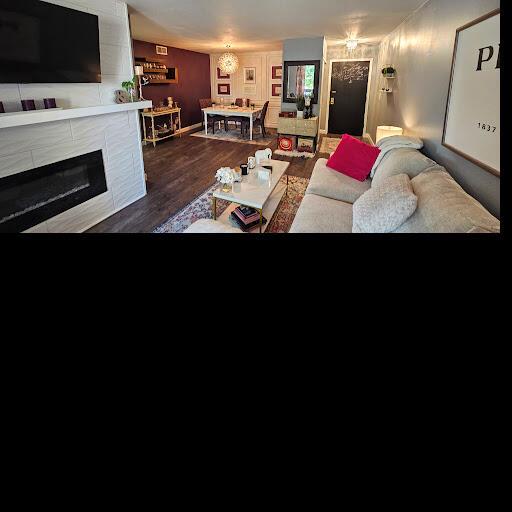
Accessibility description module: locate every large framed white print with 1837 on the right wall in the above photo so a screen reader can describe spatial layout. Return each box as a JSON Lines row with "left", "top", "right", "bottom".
{"left": 443, "top": 9, "right": 501, "bottom": 176}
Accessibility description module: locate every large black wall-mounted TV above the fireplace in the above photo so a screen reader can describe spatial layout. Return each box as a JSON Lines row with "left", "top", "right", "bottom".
{"left": 0, "top": 0, "right": 101, "bottom": 84}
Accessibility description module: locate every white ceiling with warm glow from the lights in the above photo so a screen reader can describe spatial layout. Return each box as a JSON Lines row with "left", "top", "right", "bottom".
{"left": 126, "top": 0, "right": 425, "bottom": 53}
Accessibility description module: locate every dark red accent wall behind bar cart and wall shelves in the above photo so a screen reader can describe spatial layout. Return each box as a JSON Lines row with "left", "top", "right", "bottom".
{"left": 133, "top": 40, "right": 211, "bottom": 128}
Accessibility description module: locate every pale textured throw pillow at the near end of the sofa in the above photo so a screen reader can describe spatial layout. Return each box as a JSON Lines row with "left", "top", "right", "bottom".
{"left": 353, "top": 174, "right": 418, "bottom": 233}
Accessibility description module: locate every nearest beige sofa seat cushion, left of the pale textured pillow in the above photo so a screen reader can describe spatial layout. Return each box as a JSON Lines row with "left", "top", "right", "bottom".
{"left": 290, "top": 194, "right": 352, "bottom": 233}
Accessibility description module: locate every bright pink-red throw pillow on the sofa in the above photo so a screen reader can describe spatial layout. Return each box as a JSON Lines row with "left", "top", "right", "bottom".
{"left": 327, "top": 134, "right": 380, "bottom": 181}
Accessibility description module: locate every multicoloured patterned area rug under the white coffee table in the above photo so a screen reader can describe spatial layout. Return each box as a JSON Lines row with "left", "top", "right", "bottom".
{"left": 153, "top": 176, "right": 309, "bottom": 234}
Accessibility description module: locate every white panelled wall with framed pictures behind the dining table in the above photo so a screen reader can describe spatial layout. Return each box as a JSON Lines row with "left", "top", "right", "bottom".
{"left": 210, "top": 51, "right": 283, "bottom": 128}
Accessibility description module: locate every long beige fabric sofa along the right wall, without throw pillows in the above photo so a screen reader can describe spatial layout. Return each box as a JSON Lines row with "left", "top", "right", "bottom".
{"left": 290, "top": 148, "right": 500, "bottom": 234}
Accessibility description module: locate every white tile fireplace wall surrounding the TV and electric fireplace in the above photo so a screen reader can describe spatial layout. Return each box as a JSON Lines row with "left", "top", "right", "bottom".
{"left": 0, "top": 0, "right": 146, "bottom": 233}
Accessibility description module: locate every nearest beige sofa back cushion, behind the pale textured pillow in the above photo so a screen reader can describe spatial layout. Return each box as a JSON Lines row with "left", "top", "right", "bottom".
{"left": 395, "top": 166, "right": 500, "bottom": 233}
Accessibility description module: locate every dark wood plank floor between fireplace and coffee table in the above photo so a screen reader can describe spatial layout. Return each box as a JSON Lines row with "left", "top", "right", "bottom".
{"left": 88, "top": 130, "right": 339, "bottom": 233}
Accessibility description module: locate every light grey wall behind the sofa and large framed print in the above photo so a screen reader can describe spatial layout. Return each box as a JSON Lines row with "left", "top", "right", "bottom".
{"left": 370, "top": 0, "right": 501, "bottom": 217}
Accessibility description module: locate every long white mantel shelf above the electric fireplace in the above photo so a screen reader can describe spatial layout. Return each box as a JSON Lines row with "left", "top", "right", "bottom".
{"left": 0, "top": 101, "right": 153, "bottom": 129}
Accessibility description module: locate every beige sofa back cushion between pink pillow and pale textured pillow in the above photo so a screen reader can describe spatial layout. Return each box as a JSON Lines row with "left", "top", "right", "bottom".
{"left": 372, "top": 148, "right": 437, "bottom": 187}
